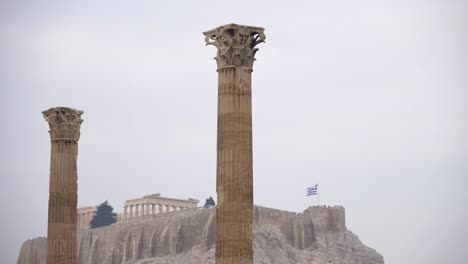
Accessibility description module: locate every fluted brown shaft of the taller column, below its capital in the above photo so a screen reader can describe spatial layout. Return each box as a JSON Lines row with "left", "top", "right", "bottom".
{"left": 216, "top": 67, "right": 253, "bottom": 264}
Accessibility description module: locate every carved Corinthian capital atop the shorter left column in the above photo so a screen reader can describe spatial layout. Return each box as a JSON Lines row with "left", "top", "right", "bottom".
{"left": 42, "top": 107, "right": 83, "bottom": 142}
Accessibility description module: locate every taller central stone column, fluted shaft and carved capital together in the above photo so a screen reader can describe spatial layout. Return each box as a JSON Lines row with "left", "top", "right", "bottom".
{"left": 203, "top": 24, "right": 265, "bottom": 264}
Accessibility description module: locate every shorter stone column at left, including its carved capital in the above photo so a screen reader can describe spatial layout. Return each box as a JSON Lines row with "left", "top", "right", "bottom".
{"left": 42, "top": 107, "right": 83, "bottom": 264}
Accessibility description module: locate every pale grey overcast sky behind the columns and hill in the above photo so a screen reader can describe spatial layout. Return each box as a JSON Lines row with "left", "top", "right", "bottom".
{"left": 0, "top": 0, "right": 468, "bottom": 264}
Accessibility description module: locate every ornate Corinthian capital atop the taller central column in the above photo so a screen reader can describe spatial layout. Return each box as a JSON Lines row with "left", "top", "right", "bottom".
{"left": 203, "top": 24, "right": 265, "bottom": 69}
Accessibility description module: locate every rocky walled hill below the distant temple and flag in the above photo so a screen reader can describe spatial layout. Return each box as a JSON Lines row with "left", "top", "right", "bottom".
{"left": 17, "top": 206, "right": 384, "bottom": 264}
